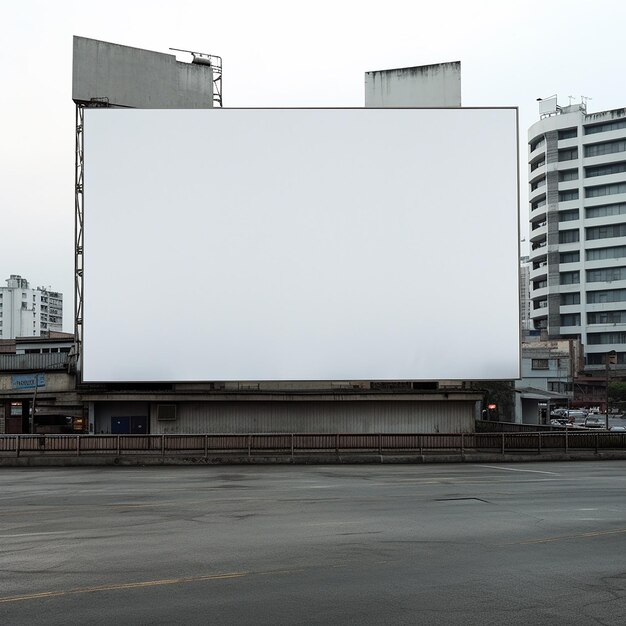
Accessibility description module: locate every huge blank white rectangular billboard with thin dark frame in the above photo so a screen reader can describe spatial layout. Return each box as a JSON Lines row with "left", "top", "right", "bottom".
{"left": 82, "top": 108, "right": 520, "bottom": 382}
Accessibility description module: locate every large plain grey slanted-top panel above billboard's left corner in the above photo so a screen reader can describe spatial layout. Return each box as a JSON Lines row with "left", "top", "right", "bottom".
{"left": 72, "top": 37, "right": 213, "bottom": 109}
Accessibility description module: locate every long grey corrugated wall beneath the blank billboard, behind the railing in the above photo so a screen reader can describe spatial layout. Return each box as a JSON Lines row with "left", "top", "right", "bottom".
{"left": 150, "top": 400, "right": 475, "bottom": 434}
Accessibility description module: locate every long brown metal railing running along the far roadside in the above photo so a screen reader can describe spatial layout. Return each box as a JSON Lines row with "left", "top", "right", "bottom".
{"left": 0, "top": 431, "right": 626, "bottom": 458}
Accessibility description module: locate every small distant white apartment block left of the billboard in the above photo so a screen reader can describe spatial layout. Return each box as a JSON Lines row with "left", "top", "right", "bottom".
{"left": 0, "top": 274, "right": 63, "bottom": 339}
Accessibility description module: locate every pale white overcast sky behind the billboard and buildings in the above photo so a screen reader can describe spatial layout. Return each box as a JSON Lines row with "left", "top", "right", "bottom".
{"left": 0, "top": 0, "right": 626, "bottom": 331}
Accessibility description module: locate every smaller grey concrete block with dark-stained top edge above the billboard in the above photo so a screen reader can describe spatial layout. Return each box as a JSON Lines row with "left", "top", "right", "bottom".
{"left": 365, "top": 61, "right": 461, "bottom": 107}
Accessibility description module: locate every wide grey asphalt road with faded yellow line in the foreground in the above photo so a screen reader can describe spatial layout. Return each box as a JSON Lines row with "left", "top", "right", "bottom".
{"left": 0, "top": 461, "right": 626, "bottom": 626}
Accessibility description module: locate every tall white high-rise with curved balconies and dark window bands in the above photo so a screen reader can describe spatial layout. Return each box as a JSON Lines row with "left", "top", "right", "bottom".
{"left": 528, "top": 98, "right": 626, "bottom": 369}
